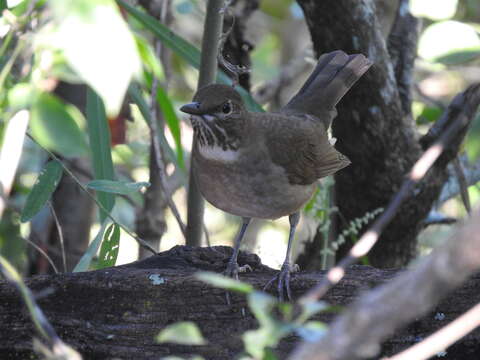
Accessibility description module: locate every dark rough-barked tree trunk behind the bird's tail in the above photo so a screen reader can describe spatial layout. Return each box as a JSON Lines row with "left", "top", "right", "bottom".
{"left": 298, "top": 0, "right": 474, "bottom": 267}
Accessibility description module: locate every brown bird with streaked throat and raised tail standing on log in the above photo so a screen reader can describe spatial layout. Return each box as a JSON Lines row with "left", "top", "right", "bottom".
{"left": 180, "top": 50, "right": 372, "bottom": 301}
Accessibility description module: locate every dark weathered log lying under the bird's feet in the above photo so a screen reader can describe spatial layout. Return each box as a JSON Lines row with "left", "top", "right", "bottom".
{"left": 0, "top": 246, "right": 480, "bottom": 359}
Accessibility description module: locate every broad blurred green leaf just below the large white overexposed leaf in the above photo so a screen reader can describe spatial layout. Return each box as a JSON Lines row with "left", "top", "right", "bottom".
{"left": 30, "top": 93, "right": 88, "bottom": 157}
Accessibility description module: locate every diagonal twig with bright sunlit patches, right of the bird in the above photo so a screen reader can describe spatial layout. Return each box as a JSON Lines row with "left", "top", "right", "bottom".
{"left": 298, "top": 84, "right": 480, "bottom": 304}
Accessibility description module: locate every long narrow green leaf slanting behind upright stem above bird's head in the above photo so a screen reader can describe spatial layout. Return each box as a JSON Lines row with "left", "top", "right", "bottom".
{"left": 117, "top": 0, "right": 263, "bottom": 111}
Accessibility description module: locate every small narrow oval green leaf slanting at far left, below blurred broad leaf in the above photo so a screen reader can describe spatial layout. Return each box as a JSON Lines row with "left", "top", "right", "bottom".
{"left": 20, "top": 160, "right": 63, "bottom": 222}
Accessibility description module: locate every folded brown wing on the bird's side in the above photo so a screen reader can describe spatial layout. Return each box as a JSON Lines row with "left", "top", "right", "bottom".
{"left": 265, "top": 114, "right": 350, "bottom": 185}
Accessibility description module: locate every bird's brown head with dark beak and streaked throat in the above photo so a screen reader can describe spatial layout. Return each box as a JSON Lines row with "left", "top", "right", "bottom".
{"left": 180, "top": 84, "right": 248, "bottom": 150}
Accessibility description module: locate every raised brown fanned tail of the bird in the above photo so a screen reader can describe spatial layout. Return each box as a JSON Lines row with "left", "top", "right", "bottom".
{"left": 282, "top": 50, "right": 373, "bottom": 126}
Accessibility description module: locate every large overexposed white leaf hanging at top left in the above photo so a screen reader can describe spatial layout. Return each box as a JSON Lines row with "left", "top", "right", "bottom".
{"left": 49, "top": 0, "right": 141, "bottom": 116}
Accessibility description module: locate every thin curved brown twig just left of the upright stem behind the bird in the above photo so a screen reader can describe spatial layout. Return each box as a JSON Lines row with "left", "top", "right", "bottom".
{"left": 149, "top": 43, "right": 187, "bottom": 239}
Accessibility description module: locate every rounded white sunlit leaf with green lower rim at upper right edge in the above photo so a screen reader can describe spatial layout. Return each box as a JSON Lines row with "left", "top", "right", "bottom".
{"left": 418, "top": 21, "right": 480, "bottom": 62}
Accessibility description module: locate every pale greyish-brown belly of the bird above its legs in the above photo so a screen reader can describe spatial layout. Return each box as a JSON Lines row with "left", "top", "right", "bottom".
{"left": 193, "top": 153, "right": 315, "bottom": 219}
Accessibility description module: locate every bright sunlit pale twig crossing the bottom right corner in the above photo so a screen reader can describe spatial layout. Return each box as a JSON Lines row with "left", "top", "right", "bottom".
{"left": 388, "top": 304, "right": 480, "bottom": 360}
